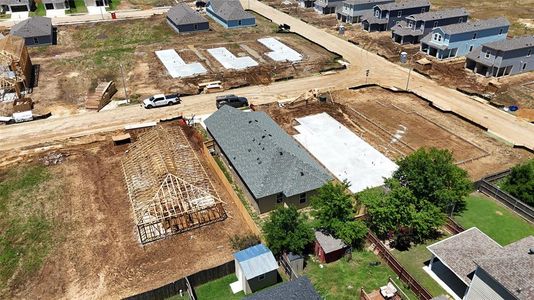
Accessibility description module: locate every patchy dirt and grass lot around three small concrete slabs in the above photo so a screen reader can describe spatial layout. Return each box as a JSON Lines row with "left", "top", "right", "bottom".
{"left": 7, "top": 12, "right": 340, "bottom": 115}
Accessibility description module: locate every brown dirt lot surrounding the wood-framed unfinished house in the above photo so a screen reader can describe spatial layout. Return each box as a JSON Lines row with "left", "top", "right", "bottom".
{"left": 0, "top": 123, "right": 255, "bottom": 299}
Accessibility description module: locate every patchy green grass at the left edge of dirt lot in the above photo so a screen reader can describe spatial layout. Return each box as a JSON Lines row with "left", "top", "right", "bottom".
{"left": 0, "top": 165, "right": 61, "bottom": 290}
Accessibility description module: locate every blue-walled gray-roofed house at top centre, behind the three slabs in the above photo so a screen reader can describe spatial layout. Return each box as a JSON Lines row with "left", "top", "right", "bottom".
{"left": 206, "top": 0, "right": 256, "bottom": 28}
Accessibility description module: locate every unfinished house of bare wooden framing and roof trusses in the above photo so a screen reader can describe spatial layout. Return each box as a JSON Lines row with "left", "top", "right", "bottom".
{"left": 122, "top": 127, "right": 227, "bottom": 244}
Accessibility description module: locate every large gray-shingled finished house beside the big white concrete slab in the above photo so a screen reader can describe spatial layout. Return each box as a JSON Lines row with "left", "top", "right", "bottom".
{"left": 205, "top": 106, "right": 332, "bottom": 213}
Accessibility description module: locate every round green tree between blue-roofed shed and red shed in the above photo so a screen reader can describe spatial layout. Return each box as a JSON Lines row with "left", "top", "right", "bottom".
{"left": 262, "top": 205, "right": 315, "bottom": 255}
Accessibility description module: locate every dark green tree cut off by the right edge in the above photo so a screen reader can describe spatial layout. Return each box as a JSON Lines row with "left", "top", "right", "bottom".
{"left": 502, "top": 159, "right": 534, "bottom": 206}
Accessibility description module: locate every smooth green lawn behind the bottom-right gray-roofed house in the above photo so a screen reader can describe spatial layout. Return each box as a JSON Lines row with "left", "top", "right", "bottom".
{"left": 455, "top": 193, "right": 534, "bottom": 246}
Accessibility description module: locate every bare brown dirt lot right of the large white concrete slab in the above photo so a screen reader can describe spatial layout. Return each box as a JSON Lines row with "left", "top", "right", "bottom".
{"left": 259, "top": 87, "right": 534, "bottom": 179}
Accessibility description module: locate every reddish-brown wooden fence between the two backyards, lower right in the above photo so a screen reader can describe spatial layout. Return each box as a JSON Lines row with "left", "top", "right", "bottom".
{"left": 367, "top": 231, "right": 432, "bottom": 300}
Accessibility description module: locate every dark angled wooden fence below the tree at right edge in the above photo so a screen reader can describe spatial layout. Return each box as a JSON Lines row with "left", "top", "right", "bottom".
{"left": 475, "top": 170, "right": 534, "bottom": 223}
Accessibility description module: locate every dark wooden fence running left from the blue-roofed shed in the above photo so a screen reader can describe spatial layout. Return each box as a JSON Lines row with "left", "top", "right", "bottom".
{"left": 124, "top": 260, "right": 235, "bottom": 300}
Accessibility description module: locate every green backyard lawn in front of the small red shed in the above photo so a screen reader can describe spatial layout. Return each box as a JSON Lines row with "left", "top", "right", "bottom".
{"left": 304, "top": 251, "right": 417, "bottom": 299}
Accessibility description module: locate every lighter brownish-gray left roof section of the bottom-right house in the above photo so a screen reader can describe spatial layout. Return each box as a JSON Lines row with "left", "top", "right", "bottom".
{"left": 427, "top": 227, "right": 501, "bottom": 284}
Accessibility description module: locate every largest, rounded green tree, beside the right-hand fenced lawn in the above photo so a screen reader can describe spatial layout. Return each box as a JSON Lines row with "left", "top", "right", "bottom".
{"left": 393, "top": 148, "right": 472, "bottom": 213}
